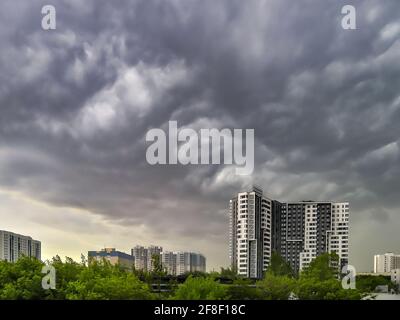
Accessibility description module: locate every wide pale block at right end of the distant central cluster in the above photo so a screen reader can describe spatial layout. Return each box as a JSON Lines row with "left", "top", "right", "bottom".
{"left": 161, "top": 251, "right": 206, "bottom": 276}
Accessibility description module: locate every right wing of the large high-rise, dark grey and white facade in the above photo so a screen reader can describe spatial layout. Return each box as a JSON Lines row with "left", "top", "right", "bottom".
{"left": 277, "top": 201, "right": 349, "bottom": 272}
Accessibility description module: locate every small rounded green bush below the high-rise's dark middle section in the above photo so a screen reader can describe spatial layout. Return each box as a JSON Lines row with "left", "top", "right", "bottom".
{"left": 257, "top": 272, "right": 296, "bottom": 300}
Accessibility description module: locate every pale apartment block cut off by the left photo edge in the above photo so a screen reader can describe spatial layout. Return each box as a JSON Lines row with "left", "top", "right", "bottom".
{"left": 0, "top": 230, "right": 41, "bottom": 262}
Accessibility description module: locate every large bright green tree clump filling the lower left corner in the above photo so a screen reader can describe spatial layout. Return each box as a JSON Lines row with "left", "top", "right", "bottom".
{"left": 0, "top": 256, "right": 154, "bottom": 300}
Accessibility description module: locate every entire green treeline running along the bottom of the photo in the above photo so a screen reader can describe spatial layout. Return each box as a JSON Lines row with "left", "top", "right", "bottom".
{"left": 0, "top": 254, "right": 387, "bottom": 300}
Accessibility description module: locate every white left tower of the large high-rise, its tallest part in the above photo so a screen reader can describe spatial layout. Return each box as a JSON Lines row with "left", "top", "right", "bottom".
{"left": 229, "top": 187, "right": 273, "bottom": 278}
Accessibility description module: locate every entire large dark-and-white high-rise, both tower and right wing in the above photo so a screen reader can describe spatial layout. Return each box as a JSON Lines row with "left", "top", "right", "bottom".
{"left": 229, "top": 187, "right": 349, "bottom": 278}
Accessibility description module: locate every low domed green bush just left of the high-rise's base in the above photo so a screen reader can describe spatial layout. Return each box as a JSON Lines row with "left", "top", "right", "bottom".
{"left": 172, "top": 276, "right": 228, "bottom": 300}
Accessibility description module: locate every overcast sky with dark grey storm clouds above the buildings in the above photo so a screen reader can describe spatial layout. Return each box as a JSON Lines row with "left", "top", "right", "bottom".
{"left": 0, "top": 0, "right": 400, "bottom": 271}
